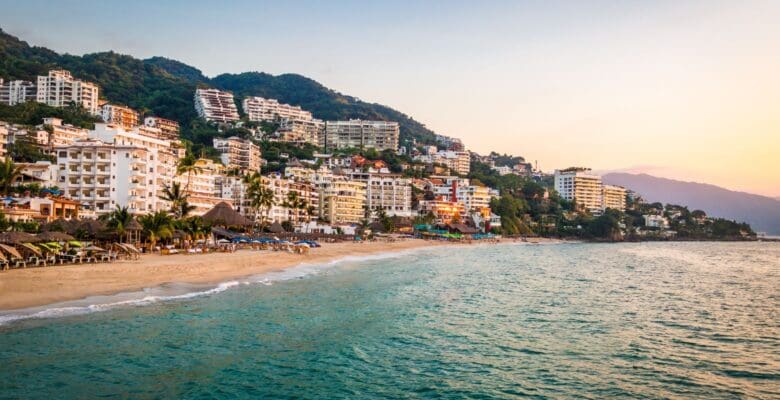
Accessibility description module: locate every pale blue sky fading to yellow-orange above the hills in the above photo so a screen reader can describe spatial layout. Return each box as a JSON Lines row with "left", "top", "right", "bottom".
{"left": 0, "top": 0, "right": 780, "bottom": 197}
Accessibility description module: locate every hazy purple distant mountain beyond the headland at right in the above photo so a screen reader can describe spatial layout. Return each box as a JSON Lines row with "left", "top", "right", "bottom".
{"left": 602, "top": 173, "right": 780, "bottom": 235}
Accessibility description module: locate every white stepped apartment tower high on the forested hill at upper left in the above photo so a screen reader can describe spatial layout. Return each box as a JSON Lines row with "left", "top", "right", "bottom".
{"left": 36, "top": 70, "right": 100, "bottom": 115}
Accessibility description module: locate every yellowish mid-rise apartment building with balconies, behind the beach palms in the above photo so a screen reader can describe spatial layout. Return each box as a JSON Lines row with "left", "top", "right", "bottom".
{"left": 319, "top": 176, "right": 366, "bottom": 224}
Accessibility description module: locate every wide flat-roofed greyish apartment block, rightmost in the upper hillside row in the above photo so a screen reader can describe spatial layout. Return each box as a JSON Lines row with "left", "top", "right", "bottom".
{"left": 324, "top": 119, "right": 399, "bottom": 151}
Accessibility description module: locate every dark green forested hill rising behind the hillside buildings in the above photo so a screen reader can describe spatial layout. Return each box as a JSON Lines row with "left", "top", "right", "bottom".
{"left": 0, "top": 29, "right": 434, "bottom": 143}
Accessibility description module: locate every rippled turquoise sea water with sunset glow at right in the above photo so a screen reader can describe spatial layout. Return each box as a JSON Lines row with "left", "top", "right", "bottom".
{"left": 0, "top": 243, "right": 780, "bottom": 399}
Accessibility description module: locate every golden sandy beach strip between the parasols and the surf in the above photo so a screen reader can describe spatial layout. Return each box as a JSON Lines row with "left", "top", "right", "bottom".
{"left": 0, "top": 239, "right": 451, "bottom": 310}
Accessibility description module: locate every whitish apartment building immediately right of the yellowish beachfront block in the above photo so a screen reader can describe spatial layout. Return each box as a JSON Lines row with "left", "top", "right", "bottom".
{"left": 344, "top": 169, "right": 414, "bottom": 217}
